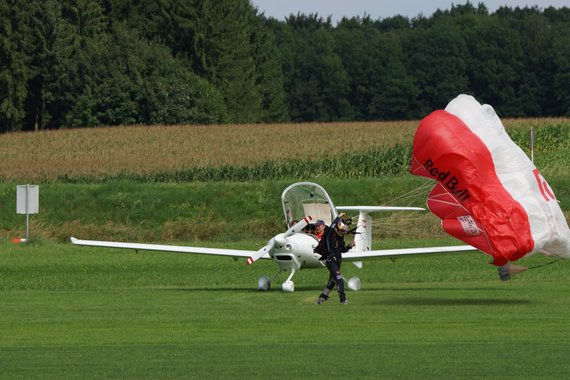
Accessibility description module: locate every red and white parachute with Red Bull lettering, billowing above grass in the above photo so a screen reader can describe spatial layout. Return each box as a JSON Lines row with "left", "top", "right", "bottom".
{"left": 411, "top": 95, "right": 570, "bottom": 266}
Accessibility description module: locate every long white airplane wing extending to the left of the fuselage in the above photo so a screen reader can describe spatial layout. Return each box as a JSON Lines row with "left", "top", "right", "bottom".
{"left": 71, "top": 237, "right": 271, "bottom": 259}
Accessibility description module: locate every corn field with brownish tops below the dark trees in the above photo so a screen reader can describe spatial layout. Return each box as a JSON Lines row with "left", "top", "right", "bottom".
{"left": 0, "top": 119, "right": 570, "bottom": 182}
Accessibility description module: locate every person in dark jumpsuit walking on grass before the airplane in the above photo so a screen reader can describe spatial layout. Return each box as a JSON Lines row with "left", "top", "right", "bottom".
{"left": 315, "top": 216, "right": 352, "bottom": 305}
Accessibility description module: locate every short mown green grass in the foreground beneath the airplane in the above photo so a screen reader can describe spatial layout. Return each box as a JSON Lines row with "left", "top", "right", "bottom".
{"left": 0, "top": 242, "right": 570, "bottom": 379}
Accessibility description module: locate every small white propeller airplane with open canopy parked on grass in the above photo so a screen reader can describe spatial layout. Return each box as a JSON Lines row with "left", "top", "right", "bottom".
{"left": 71, "top": 182, "right": 476, "bottom": 292}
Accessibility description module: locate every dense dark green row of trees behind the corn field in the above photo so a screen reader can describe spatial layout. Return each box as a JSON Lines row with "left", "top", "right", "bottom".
{"left": 0, "top": 0, "right": 570, "bottom": 132}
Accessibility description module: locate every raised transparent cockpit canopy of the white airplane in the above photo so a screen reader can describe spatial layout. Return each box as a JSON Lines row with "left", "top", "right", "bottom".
{"left": 281, "top": 182, "right": 337, "bottom": 228}
